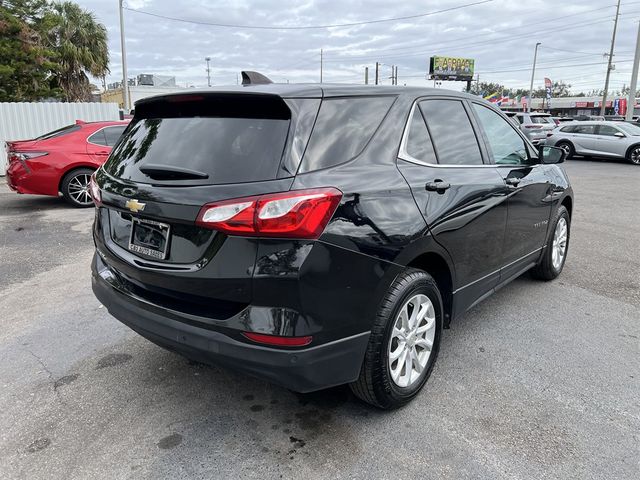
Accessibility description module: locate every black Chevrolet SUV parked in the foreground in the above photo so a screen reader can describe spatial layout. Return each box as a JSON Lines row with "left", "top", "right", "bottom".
{"left": 91, "top": 84, "right": 573, "bottom": 408}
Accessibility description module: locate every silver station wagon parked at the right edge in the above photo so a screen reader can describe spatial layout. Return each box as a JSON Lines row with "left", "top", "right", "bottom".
{"left": 545, "top": 121, "right": 640, "bottom": 165}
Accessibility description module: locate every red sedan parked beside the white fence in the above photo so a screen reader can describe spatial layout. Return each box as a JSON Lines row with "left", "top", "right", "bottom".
{"left": 7, "top": 120, "right": 129, "bottom": 207}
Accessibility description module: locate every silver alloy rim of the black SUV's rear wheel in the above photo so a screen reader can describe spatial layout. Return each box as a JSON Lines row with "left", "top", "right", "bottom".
{"left": 388, "top": 294, "right": 436, "bottom": 388}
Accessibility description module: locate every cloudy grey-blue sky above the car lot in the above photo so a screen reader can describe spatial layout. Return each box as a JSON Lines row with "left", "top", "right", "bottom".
{"left": 76, "top": 0, "right": 640, "bottom": 92}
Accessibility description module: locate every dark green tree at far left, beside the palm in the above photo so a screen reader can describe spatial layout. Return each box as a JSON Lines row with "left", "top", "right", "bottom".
{"left": 0, "top": 0, "right": 59, "bottom": 102}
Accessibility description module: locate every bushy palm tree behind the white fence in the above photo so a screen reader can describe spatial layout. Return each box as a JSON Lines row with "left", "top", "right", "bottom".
{"left": 45, "top": 1, "right": 109, "bottom": 102}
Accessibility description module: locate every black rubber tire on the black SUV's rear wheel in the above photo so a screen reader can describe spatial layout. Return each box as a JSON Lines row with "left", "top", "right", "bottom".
{"left": 350, "top": 269, "right": 443, "bottom": 409}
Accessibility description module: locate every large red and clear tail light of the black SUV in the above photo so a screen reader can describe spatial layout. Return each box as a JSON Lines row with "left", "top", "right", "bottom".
{"left": 196, "top": 188, "right": 342, "bottom": 239}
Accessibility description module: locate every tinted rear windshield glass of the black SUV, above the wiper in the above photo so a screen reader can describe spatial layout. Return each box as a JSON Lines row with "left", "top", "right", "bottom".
{"left": 104, "top": 116, "right": 290, "bottom": 184}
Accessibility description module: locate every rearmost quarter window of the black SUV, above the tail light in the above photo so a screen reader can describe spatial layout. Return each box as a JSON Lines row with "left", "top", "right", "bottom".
{"left": 300, "top": 96, "right": 395, "bottom": 173}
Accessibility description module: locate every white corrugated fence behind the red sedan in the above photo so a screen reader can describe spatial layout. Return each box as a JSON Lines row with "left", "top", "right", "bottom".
{"left": 0, "top": 103, "right": 120, "bottom": 175}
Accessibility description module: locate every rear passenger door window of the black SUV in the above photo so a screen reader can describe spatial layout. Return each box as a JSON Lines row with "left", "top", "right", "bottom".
{"left": 419, "top": 100, "right": 482, "bottom": 165}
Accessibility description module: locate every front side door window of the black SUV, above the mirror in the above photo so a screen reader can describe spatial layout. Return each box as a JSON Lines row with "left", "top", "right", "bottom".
{"left": 473, "top": 103, "right": 529, "bottom": 165}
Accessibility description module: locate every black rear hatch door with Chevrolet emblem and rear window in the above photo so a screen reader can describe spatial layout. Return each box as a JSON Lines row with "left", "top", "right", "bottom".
{"left": 95, "top": 93, "right": 320, "bottom": 316}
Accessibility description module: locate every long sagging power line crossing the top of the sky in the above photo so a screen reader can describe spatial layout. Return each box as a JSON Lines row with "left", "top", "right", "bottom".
{"left": 124, "top": 0, "right": 494, "bottom": 30}
